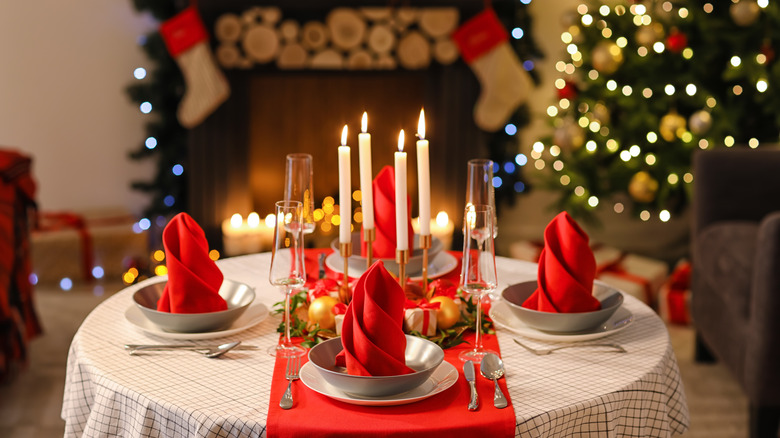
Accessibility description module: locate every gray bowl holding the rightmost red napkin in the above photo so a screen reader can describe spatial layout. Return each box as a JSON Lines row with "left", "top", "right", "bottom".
{"left": 501, "top": 280, "right": 623, "bottom": 333}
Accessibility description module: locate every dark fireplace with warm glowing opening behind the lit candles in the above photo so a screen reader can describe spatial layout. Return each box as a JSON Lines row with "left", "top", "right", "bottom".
{"left": 188, "top": 1, "right": 487, "bottom": 248}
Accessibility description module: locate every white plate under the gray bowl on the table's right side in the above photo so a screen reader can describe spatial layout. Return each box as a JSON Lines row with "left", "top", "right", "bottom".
{"left": 488, "top": 300, "right": 634, "bottom": 342}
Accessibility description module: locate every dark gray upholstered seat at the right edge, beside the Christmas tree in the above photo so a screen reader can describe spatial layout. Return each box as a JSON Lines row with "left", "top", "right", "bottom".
{"left": 692, "top": 147, "right": 780, "bottom": 438}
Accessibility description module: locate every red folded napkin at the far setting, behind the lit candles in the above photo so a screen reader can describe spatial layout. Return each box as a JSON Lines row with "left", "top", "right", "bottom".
{"left": 360, "top": 166, "right": 414, "bottom": 259}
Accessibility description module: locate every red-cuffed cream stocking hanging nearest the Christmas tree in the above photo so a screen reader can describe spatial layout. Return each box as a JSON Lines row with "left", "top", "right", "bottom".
{"left": 452, "top": 8, "right": 532, "bottom": 132}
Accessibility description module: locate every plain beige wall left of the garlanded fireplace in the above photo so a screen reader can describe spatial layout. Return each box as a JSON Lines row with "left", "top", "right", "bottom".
{"left": 0, "top": 0, "right": 156, "bottom": 213}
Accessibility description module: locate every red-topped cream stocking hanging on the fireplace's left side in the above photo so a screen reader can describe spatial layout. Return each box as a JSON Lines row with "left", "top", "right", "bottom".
{"left": 160, "top": 6, "right": 230, "bottom": 128}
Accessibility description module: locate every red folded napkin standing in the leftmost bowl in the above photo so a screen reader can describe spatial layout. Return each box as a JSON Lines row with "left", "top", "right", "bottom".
{"left": 157, "top": 213, "right": 227, "bottom": 313}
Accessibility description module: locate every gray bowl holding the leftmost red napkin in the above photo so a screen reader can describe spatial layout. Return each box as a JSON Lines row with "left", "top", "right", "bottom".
{"left": 133, "top": 278, "right": 255, "bottom": 333}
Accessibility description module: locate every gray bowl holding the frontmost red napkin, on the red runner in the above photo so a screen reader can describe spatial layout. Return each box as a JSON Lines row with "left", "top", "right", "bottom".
{"left": 309, "top": 335, "right": 444, "bottom": 397}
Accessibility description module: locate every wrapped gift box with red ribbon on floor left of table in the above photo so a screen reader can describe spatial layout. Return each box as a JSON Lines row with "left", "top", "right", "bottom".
{"left": 30, "top": 209, "right": 149, "bottom": 283}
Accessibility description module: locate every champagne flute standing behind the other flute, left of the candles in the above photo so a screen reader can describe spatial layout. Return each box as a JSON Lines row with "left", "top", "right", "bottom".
{"left": 284, "top": 153, "right": 315, "bottom": 234}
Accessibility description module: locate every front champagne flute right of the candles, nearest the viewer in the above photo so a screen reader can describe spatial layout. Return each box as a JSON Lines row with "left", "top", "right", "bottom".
{"left": 458, "top": 204, "right": 498, "bottom": 363}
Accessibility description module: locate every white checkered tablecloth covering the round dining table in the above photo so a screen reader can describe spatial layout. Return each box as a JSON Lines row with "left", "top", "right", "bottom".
{"left": 62, "top": 253, "right": 689, "bottom": 437}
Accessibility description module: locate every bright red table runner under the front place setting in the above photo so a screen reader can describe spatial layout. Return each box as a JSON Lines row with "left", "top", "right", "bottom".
{"left": 266, "top": 250, "right": 515, "bottom": 438}
